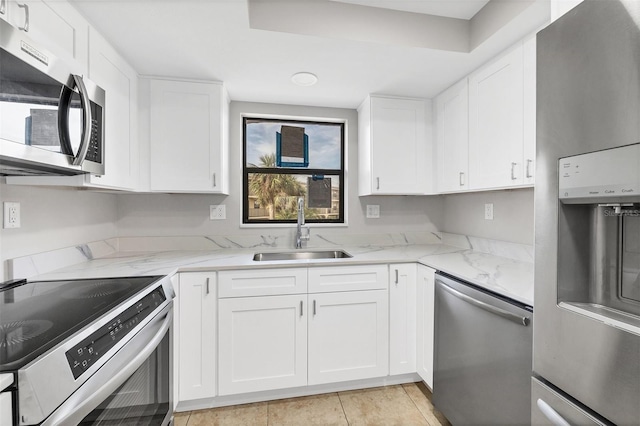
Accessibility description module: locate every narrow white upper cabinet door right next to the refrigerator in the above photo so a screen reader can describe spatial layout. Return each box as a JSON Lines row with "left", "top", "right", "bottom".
{"left": 522, "top": 36, "right": 536, "bottom": 185}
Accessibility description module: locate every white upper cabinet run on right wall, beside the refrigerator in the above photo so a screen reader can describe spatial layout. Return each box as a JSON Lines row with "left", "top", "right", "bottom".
{"left": 436, "top": 37, "right": 536, "bottom": 193}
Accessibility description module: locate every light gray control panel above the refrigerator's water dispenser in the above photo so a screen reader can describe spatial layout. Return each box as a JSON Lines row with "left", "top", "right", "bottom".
{"left": 558, "top": 143, "right": 640, "bottom": 203}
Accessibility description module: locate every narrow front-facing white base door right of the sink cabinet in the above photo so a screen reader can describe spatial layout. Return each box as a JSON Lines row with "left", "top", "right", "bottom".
{"left": 389, "top": 263, "right": 416, "bottom": 375}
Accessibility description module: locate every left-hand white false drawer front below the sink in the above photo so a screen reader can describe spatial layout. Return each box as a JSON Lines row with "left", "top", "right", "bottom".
{"left": 218, "top": 268, "right": 307, "bottom": 298}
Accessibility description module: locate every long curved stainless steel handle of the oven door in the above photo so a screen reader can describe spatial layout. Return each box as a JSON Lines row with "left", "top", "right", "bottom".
{"left": 42, "top": 303, "right": 173, "bottom": 425}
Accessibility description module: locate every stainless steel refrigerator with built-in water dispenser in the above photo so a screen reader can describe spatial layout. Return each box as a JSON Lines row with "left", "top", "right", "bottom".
{"left": 531, "top": 0, "right": 640, "bottom": 425}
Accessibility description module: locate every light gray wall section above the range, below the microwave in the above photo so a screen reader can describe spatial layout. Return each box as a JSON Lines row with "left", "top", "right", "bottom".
{"left": 0, "top": 183, "right": 117, "bottom": 280}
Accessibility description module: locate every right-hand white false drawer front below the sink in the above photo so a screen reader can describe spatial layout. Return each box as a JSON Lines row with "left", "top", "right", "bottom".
{"left": 309, "top": 265, "right": 389, "bottom": 293}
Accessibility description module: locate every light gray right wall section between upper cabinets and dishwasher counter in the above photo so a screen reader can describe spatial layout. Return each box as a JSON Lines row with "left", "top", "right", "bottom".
{"left": 441, "top": 188, "right": 533, "bottom": 244}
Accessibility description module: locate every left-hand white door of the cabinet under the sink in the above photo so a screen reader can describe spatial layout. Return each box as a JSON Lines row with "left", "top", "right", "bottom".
{"left": 218, "top": 295, "right": 308, "bottom": 395}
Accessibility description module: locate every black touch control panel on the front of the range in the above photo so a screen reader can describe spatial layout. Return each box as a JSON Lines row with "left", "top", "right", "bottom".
{"left": 65, "top": 286, "right": 167, "bottom": 379}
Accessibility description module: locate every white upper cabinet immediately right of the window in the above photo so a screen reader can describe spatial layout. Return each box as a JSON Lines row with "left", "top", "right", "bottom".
{"left": 358, "top": 96, "right": 433, "bottom": 195}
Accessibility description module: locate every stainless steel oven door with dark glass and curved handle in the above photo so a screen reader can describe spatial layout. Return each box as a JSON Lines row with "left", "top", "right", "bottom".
{"left": 42, "top": 302, "right": 173, "bottom": 425}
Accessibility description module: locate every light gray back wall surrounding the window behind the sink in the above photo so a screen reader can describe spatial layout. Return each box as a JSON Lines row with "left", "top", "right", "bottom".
{"left": 117, "top": 102, "right": 443, "bottom": 241}
